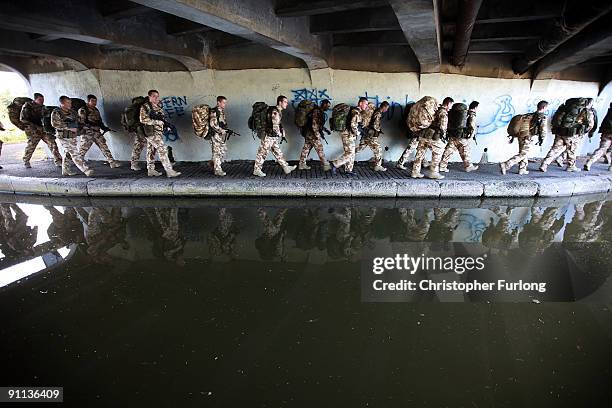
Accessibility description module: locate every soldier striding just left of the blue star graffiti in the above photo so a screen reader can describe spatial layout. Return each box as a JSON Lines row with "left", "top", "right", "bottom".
{"left": 253, "top": 95, "right": 297, "bottom": 177}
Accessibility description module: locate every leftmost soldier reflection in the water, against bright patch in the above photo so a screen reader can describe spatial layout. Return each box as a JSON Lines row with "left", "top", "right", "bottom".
{"left": 0, "top": 204, "right": 38, "bottom": 258}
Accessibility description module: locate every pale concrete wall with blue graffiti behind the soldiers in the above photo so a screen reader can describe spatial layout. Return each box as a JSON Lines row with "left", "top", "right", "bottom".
{"left": 30, "top": 68, "right": 612, "bottom": 161}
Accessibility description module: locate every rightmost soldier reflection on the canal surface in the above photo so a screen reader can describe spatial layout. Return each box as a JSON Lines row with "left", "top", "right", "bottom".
{"left": 563, "top": 201, "right": 604, "bottom": 242}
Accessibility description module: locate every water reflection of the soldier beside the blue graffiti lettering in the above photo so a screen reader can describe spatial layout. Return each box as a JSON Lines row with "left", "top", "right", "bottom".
{"left": 144, "top": 208, "right": 185, "bottom": 266}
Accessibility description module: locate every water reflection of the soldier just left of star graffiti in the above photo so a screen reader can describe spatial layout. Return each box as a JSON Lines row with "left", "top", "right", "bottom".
{"left": 255, "top": 208, "right": 287, "bottom": 261}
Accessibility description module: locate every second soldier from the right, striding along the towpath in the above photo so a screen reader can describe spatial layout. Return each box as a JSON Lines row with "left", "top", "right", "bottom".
{"left": 540, "top": 98, "right": 595, "bottom": 172}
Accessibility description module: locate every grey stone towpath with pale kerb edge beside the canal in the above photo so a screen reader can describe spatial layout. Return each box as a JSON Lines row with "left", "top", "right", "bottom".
{"left": 0, "top": 160, "right": 612, "bottom": 198}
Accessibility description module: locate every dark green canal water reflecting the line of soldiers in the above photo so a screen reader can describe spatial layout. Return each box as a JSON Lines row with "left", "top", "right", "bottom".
{"left": 0, "top": 195, "right": 612, "bottom": 407}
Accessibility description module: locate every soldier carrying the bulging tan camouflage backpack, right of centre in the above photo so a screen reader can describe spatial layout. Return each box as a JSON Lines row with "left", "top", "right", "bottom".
{"left": 410, "top": 96, "right": 455, "bottom": 179}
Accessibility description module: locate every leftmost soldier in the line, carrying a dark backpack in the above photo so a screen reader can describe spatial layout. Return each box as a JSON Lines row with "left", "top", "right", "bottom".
{"left": 19, "top": 92, "right": 62, "bottom": 169}
